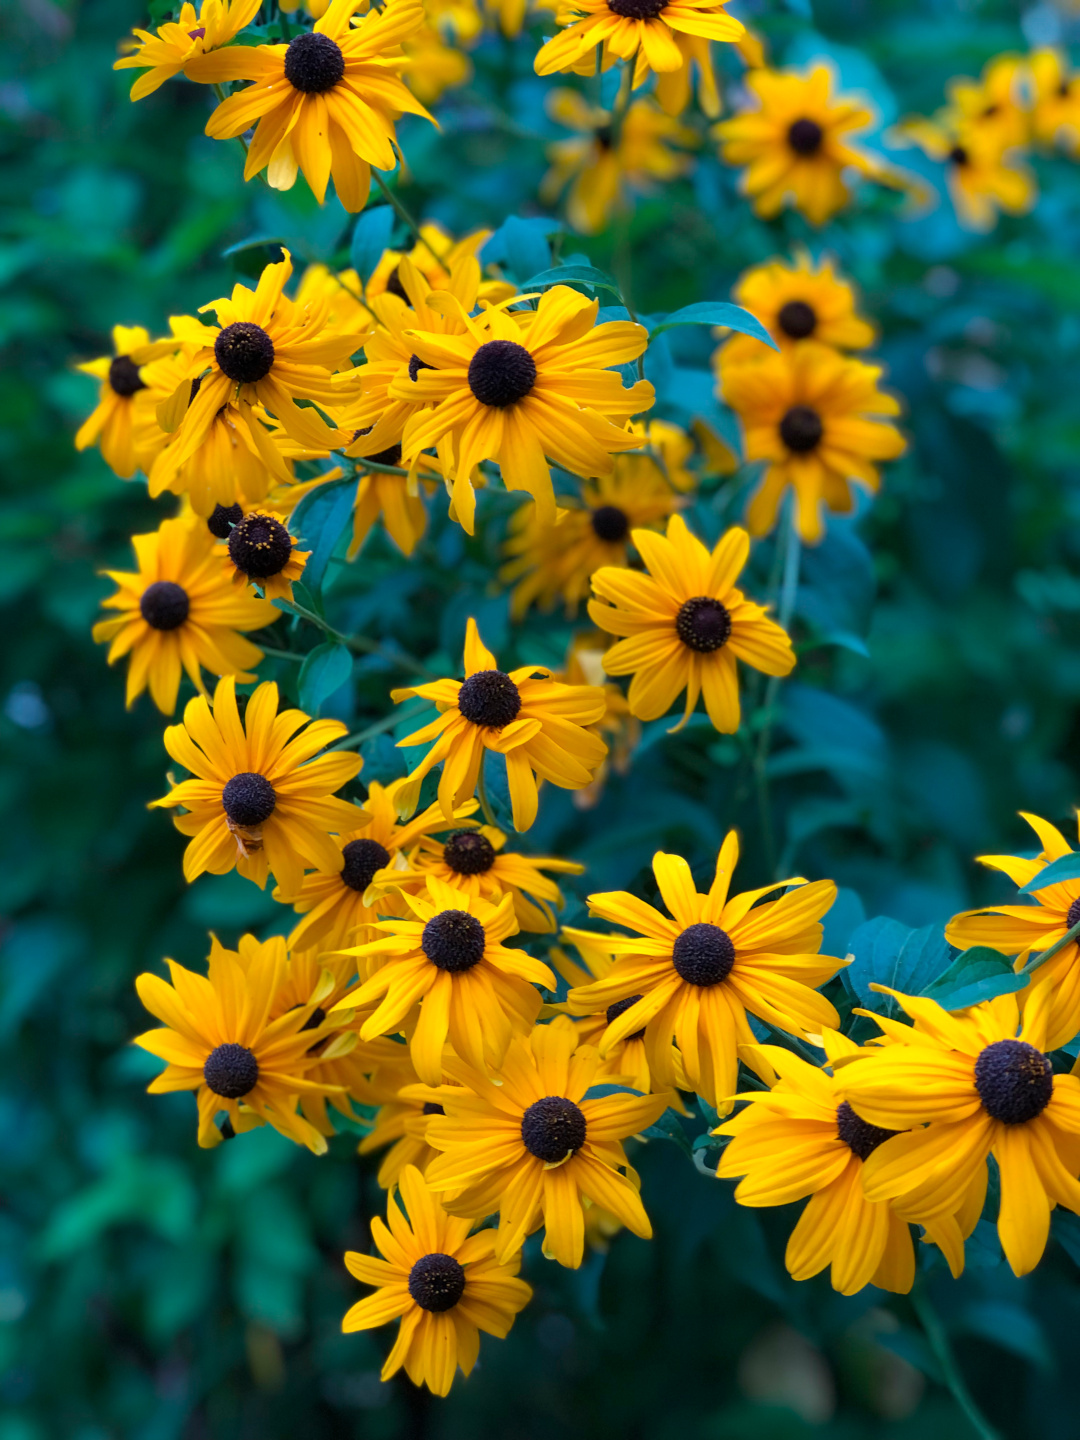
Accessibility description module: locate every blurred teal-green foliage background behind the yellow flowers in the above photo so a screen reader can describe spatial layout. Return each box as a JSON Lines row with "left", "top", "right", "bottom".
{"left": 0, "top": 0, "right": 1080, "bottom": 1440}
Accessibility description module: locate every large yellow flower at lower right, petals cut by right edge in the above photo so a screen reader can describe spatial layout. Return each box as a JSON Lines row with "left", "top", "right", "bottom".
{"left": 838, "top": 981, "right": 1080, "bottom": 1274}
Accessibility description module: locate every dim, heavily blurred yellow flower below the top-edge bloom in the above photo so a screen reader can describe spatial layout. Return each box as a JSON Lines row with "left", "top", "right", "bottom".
{"left": 540, "top": 87, "right": 707, "bottom": 235}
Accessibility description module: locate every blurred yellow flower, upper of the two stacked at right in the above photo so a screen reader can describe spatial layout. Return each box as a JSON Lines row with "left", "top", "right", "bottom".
{"left": 716, "top": 251, "right": 874, "bottom": 367}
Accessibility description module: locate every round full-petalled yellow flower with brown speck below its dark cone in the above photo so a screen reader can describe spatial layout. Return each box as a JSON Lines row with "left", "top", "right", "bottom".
{"left": 151, "top": 677, "right": 366, "bottom": 894}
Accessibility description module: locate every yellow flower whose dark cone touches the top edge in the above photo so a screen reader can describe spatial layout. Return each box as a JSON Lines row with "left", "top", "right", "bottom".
{"left": 533, "top": 0, "right": 744, "bottom": 89}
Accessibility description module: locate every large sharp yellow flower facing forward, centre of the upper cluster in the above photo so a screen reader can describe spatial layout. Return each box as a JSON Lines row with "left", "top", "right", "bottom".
{"left": 389, "top": 285, "right": 655, "bottom": 534}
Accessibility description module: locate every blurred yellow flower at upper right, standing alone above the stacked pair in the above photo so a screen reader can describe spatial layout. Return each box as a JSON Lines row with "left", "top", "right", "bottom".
{"left": 713, "top": 63, "right": 899, "bottom": 225}
